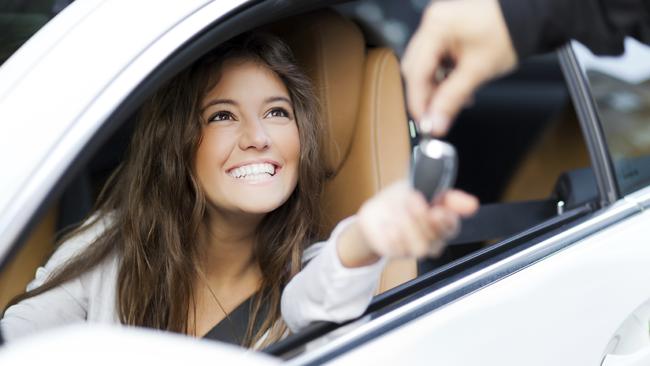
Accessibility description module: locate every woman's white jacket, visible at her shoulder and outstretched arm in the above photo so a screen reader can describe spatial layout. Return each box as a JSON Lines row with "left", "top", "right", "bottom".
{"left": 0, "top": 219, "right": 385, "bottom": 341}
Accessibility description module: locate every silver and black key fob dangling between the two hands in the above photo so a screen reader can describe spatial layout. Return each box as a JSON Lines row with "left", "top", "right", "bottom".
{"left": 411, "top": 138, "right": 457, "bottom": 202}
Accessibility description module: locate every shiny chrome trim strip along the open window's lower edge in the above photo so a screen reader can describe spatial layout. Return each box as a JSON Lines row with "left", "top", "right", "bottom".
{"left": 288, "top": 199, "right": 650, "bottom": 365}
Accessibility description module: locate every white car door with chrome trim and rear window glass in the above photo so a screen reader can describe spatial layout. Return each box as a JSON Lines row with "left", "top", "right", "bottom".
{"left": 282, "top": 40, "right": 650, "bottom": 365}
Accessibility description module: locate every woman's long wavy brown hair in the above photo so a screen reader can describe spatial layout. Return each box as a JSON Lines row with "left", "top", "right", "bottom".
{"left": 4, "top": 33, "right": 327, "bottom": 347}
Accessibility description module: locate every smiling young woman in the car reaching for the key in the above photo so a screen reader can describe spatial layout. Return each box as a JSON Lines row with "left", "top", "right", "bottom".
{"left": 0, "top": 34, "right": 476, "bottom": 347}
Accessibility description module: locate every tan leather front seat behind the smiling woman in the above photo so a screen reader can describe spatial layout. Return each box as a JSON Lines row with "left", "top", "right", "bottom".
{"left": 270, "top": 10, "right": 416, "bottom": 290}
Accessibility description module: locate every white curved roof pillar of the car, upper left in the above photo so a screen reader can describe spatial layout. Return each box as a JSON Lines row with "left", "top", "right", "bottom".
{"left": 0, "top": 0, "right": 245, "bottom": 256}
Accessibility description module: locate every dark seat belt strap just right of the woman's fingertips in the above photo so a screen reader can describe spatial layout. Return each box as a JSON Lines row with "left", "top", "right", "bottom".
{"left": 448, "top": 198, "right": 558, "bottom": 245}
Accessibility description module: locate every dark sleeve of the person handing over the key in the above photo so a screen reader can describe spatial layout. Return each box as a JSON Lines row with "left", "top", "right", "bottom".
{"left": 499, "top": 0, "right": 650, "bottom": 59}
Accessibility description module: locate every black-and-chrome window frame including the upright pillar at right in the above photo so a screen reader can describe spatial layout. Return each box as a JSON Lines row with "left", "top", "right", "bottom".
{"left": 265, "top": 41, "right": 650, "bottom": 364}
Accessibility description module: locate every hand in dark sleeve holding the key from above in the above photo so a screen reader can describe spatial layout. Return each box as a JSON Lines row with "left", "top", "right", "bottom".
{"left": 402, "top": 0, "right": 517, "bottom": 136}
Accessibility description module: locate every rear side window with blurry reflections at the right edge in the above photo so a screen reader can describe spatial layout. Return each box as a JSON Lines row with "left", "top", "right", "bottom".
{"left": 573, "top": 38, "right": 650, "bottom": 194}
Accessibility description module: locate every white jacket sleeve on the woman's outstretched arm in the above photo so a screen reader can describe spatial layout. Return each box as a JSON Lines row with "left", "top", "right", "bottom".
{"left": 281, "top": 218, "right": 386, "bottom": 333}
